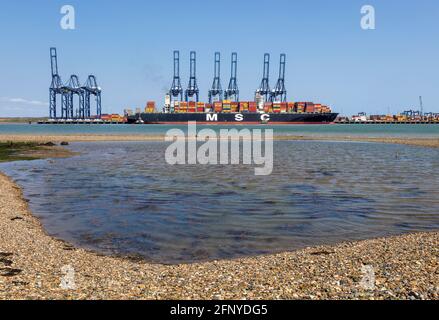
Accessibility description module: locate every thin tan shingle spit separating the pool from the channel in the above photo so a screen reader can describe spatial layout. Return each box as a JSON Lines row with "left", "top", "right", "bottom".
{"left": 0, "top": 134, "right": 439, "bottom": 148}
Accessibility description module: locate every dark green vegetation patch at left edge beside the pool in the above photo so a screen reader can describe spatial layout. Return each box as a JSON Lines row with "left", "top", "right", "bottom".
{"left": 0, "top": 142, "right": 53, "bottom": 162}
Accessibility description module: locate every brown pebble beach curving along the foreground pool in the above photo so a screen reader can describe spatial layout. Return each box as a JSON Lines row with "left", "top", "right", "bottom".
{"left": 0, "top": 174, "right": 439, "bottom": 299}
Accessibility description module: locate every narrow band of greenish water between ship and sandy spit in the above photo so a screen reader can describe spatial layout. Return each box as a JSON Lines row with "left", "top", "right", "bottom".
{"left": 0, "top": 124, "right": 439, "bottom": 137}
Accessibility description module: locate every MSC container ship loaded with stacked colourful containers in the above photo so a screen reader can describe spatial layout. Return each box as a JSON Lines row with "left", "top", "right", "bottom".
{"left": 125, "top": 100, "right": 338, "bottom": 125}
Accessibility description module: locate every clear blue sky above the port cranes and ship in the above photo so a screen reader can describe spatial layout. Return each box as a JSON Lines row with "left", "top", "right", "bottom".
{"left": 0, "top": 0, "right": 439, "bottom": 117}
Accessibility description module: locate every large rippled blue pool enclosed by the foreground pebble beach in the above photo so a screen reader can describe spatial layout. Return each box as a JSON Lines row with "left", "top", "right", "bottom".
{"left": 0, "top": 141, "right": 439, "bottom": 263}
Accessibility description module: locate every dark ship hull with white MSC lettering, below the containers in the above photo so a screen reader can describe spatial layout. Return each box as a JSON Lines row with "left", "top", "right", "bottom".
{"left": 128, "top": 113, "right": 338, "bottom": 125}
